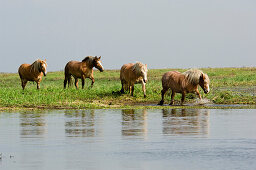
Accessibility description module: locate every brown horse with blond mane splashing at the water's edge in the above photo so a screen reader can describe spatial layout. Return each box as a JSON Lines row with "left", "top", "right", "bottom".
{"left": 159, "top": 69, "right": 210, "bottom": 105}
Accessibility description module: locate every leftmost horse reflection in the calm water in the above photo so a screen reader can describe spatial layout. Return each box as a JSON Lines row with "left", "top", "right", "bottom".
{"left": 20, "top": 112, "right": 47, "bottom": 138}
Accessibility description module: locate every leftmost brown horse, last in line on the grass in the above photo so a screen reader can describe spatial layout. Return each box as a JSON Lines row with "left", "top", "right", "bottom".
{"left": 18, "top": 59, "right": 47, "bottom": 90}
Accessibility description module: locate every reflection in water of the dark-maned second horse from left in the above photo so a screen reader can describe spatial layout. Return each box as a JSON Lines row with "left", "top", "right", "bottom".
{"left": 65, "top": 110, "right": 99, "bottom": 137}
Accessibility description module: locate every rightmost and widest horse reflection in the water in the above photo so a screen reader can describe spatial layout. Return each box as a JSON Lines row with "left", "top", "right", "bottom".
{"left": 163, "top": 109, "right": 209, "bottom": 136}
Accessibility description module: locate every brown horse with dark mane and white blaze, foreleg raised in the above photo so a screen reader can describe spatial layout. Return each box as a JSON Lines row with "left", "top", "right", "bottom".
{"left": 64, "top": 56, "right": 104, "bottom": 89}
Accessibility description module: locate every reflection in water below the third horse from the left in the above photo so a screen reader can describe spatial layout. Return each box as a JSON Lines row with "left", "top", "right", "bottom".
{"left": 122, "top": 109, "right": 148, "bottom": 137}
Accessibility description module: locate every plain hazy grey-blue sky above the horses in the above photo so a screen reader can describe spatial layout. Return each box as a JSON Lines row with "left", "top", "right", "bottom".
{"left": 0, "top": 0, "right": 256, "bottom": 72}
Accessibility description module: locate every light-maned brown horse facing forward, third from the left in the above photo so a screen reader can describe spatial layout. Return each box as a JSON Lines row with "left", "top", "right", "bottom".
{"left": 120, "top": 62, "right": 148, "bottom": 98}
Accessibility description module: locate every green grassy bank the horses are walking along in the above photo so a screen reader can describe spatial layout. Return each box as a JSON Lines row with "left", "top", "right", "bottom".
{"left": 0, "top": 68, "right": 256, "bottom": 109}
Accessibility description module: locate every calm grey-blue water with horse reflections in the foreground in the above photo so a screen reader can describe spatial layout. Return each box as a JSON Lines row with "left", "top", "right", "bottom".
{"left": 0, "top": 109, "right": 256, "bottom": 170}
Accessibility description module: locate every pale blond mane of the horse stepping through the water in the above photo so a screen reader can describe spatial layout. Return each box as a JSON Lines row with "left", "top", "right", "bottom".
{"left": 182, "top": 69, "right": 210, "bottom": 85}
